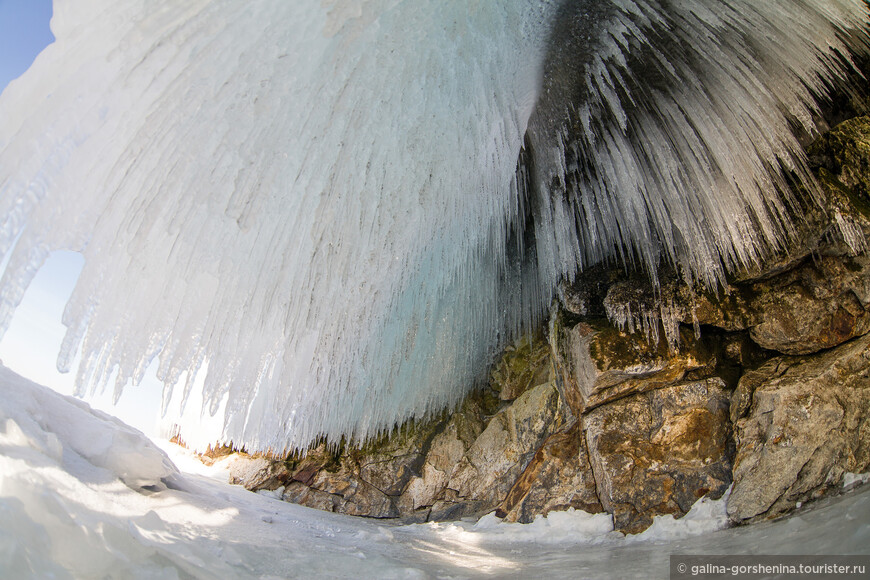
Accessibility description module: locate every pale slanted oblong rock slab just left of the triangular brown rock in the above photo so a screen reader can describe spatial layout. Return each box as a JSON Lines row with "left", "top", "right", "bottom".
{"left": 450, "top": 383, "right": 567, "bottom": 516}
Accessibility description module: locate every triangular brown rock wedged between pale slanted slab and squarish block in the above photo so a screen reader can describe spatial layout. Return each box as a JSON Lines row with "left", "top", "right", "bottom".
{"left": 496, "top": 422, "right": 604, "bottom": 523}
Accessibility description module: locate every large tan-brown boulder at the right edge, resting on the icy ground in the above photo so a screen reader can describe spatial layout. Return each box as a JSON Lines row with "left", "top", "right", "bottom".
{"left": 728, "top": 336, "right": 870, "bottom": 522}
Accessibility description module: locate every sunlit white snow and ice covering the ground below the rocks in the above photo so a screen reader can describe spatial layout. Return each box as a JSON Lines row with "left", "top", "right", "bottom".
{"left": 0, "top": 367, "right": 870, "bottom": 579}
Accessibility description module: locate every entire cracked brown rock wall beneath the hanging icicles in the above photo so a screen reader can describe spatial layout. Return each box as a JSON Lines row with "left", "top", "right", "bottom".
{"left": 220, "top": 118, "right": 870, "bottom": 533}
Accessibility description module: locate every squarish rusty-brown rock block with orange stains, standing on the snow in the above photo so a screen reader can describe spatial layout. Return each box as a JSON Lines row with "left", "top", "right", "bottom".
{"left": 584, "top": 378, "right": 731, "bottom": 533}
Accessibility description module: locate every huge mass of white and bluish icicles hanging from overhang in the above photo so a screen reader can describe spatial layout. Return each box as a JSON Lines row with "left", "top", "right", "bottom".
{"left": 0, "top": 0, "right": 867, "bottom": 450}
